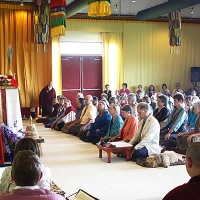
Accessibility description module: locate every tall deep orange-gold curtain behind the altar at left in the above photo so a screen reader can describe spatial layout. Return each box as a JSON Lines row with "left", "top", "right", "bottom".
{"left": 0, "top": 4, "right": 52, "bottom": 107}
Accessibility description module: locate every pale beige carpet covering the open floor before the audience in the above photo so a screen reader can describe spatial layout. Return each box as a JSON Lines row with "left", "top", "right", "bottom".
{"left": 30, "top": 121, "right": 189, "bottom": 200}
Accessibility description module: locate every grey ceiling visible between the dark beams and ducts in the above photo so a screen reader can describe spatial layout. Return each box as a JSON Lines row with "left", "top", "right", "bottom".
{"left": 2, "top": 0, "right": 200, "bottom": 19}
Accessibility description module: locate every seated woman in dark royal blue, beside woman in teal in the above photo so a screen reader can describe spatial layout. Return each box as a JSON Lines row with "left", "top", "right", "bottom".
{"left": 80, "top": 100, "right": 111, "bottom": 144}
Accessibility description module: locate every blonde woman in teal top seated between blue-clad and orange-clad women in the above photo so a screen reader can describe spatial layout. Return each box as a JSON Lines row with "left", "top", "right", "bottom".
{"left": 100, "top": 104, "right": 124, "bottom": 142}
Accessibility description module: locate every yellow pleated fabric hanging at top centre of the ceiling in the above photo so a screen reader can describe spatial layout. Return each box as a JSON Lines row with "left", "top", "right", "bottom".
{"left": 88, "top": 0, "right": 111, "bottom": 17}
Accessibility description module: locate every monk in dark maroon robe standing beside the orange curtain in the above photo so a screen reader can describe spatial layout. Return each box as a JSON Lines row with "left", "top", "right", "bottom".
{"left": 39, "top": 82, "right": 56, "bottom": 117}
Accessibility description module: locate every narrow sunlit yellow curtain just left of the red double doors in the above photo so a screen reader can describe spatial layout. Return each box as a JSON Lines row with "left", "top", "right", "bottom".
{"left": 52, "top": 36, "right": 62, "bottom": 94}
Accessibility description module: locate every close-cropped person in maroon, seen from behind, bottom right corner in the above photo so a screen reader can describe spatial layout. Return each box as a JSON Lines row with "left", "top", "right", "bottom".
{"left": 163, "top": 142, "right": 200, "bottom": 200}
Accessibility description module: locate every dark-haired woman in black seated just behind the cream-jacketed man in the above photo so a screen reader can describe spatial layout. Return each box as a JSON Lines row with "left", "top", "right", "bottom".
{"left": 153, "top": 95, "right": 170, "bottom": 125}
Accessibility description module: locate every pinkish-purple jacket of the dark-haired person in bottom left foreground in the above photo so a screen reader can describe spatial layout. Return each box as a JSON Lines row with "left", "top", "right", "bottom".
{"left": 0, "top": 189, "right": 65, "bottom": 200}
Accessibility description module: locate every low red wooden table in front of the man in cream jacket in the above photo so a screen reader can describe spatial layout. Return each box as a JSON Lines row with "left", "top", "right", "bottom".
{"left": 96, "top": 144, "right": 132, "bottom": 163}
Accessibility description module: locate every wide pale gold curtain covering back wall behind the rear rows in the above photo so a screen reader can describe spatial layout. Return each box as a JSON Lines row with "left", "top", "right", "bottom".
{"left": 123, "top": 22, "right": 200, "bottom": 91}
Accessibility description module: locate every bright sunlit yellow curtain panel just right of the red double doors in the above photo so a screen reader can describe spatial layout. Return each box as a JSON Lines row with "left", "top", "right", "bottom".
{"left": 102, "top": 33, "right": 123, "bottom": 95}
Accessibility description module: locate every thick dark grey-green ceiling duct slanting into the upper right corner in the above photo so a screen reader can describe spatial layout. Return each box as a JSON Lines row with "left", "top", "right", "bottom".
{"left": 136, "top": 0, "right": 200, "bottom": 20}
